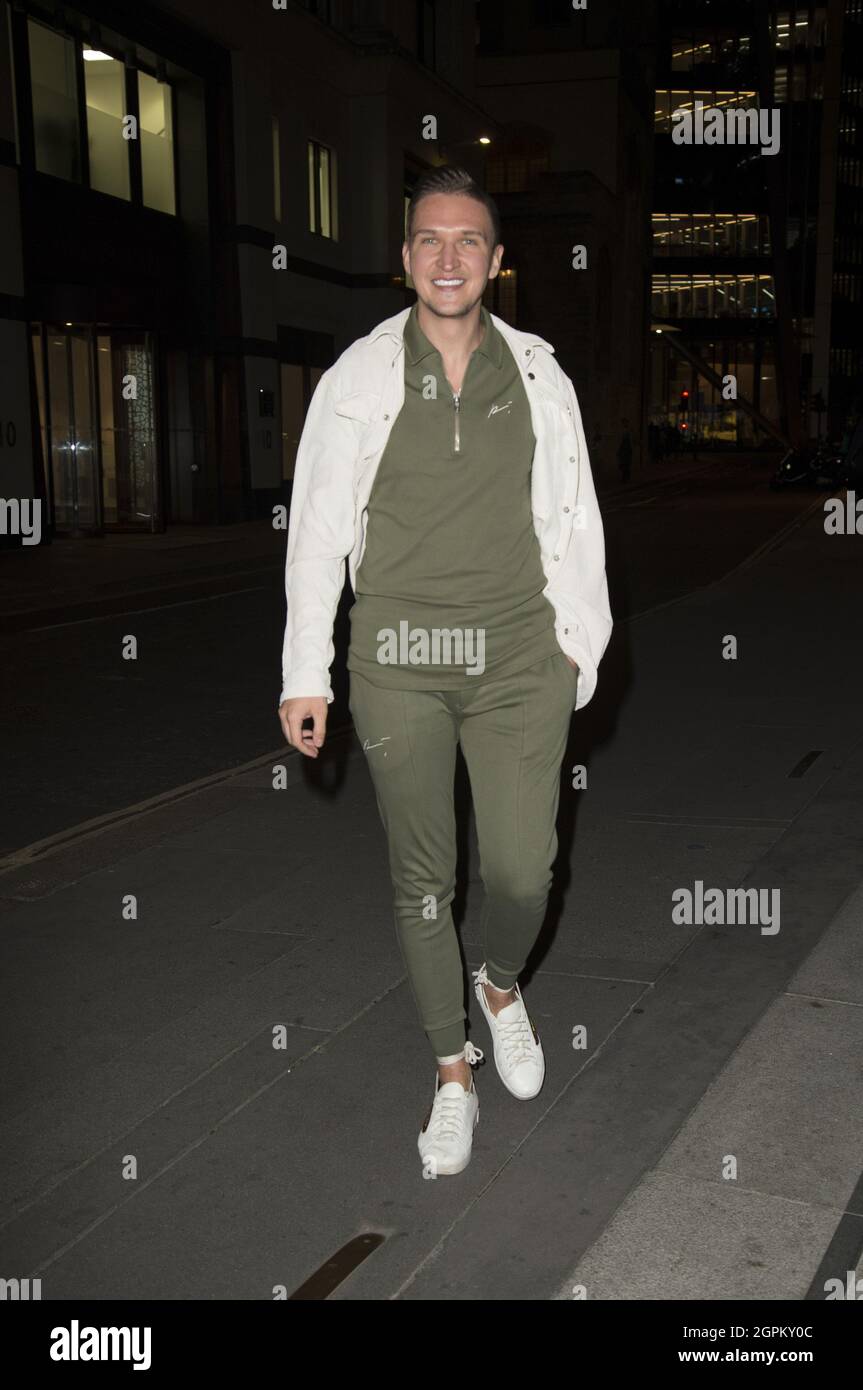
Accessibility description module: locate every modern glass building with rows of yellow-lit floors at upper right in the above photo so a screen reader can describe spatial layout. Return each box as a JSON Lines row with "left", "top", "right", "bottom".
{"left": 650, "top": 0, "right": 863, "bottom": 448}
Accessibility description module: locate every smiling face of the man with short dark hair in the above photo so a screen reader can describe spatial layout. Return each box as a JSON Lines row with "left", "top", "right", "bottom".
{"left": 402, "top": 193, "right": 503, "bottom": 318}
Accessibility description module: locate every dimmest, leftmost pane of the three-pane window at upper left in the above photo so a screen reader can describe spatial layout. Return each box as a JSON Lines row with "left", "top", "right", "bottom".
{"left": 28, "top": 19, "right": 81, "bottom": 183}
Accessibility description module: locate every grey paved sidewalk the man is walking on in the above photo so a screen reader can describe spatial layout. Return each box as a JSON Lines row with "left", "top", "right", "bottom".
{"left": 0, "top": 494, "right": 863, "bottom": 1300}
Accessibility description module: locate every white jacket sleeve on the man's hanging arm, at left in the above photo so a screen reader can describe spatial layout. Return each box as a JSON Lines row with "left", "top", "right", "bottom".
{"left": 279, "top": 367, "right": 357, "bottom": 705}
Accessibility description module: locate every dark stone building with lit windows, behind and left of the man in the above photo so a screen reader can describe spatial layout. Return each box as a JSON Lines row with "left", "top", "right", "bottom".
{"left": 0, "top": 0, "right": 655, "bottom": 542}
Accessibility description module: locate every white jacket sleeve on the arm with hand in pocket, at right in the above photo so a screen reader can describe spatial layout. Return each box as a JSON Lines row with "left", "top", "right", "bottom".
{"left": 554, "top": 371, "right": 613, "bottom": 710}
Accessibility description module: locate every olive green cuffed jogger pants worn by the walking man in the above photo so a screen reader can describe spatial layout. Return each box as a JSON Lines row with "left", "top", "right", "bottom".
{"left": 349, "top": 652, "right": 578, "bottom": 1061}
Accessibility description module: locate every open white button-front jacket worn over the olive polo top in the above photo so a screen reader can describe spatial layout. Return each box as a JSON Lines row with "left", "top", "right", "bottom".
{"left": 279, "top": 309, "right": 611, "bottom": 709}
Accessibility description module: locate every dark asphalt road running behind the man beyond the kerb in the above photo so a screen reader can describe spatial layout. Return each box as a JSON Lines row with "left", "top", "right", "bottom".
{"left": 0, "top": 460, "right": 813, "bottom": 855}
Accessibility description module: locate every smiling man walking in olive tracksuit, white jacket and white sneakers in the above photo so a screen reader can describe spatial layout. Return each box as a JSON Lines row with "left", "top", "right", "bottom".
{"left": 279, "top": 168, "right": 611, "bottom": 1173}
